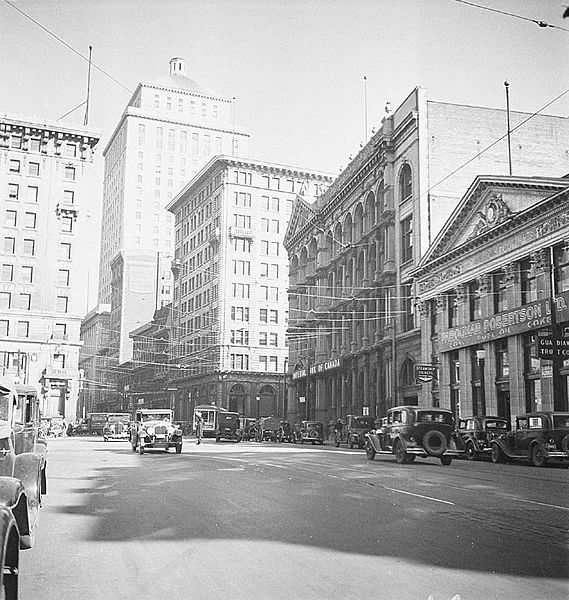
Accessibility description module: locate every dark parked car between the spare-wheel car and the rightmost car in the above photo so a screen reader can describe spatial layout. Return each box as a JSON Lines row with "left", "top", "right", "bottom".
{"left": 455, "top": 415, "right": 510, "bottom": 460}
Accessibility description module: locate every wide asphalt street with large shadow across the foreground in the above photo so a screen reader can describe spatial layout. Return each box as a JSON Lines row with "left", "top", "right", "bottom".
{"left": 20, "top": 438, "right": 569, "bottom": 600}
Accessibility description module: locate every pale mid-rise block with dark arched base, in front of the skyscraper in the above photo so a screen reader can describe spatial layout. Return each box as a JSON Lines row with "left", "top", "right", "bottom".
{"left": 164, "top": 156, "right": 332, "bottom": 420}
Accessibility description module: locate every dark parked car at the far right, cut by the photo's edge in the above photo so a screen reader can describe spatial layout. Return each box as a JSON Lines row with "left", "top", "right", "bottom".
{"left": 491, "top": 411, "right": 569, "bottom": 467}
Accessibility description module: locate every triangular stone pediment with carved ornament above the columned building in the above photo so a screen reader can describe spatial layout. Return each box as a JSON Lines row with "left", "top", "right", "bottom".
{"left": 421, "top": 176, "right": 569, "bottom": 264}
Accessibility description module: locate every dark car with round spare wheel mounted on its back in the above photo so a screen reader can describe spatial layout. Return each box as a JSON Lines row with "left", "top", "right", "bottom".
{"left": 365, "top": 406, "right": 460, "bottom": 465}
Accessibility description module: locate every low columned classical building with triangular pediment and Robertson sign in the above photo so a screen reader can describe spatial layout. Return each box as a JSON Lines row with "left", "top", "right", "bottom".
{"left": 415, "top": 176, "right": 569, "bottom": 419}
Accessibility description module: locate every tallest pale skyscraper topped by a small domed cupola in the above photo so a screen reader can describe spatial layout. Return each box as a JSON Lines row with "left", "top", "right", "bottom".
{"left": 99, "top": 58, "right": 249, "bottom": 363}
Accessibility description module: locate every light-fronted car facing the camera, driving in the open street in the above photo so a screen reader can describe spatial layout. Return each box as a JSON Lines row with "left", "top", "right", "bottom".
{"left": 130, "top": 408, "right": 182, "bottom": 454}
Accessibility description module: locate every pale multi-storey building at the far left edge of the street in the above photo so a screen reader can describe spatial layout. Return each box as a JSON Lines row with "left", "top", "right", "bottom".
{"left": 0, "top": 116, "right": 99, "bottom": 419}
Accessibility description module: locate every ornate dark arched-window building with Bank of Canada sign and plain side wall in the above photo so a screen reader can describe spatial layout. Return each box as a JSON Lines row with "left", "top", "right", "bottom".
{"left": 285, "top": 88, "right": 569, "bottom": 423}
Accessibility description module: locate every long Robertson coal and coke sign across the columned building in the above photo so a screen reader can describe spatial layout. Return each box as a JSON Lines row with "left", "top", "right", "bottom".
{"left": 439, "top": 292, "right": 569, "bottom": 352}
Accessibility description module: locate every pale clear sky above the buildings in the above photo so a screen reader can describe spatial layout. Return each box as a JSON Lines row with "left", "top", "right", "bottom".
{"left": 0, "top": 0, "right": 569, "bottom": 308}
